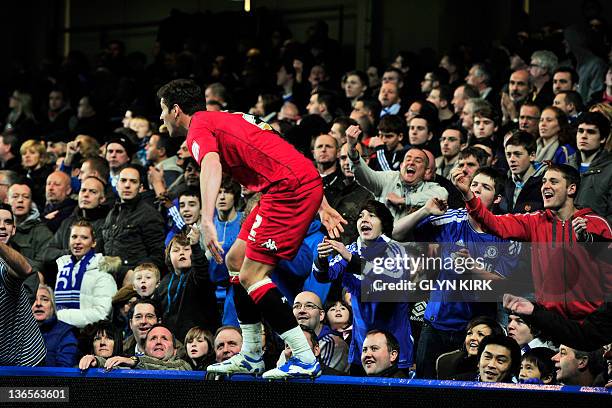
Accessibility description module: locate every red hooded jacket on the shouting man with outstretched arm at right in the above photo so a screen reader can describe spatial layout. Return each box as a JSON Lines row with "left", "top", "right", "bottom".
{"left": 466, "top": 197, "right": 612, "bottom": 320}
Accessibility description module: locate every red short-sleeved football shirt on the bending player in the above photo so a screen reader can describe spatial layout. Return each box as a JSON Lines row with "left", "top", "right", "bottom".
{"left": 187, "top": 111, "right": 320, "bottom": 192}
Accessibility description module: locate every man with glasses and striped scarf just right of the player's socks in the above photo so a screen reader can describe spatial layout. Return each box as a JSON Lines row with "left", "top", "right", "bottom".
{"left": 293, "top": 292, "right": 349, "bottom": 372}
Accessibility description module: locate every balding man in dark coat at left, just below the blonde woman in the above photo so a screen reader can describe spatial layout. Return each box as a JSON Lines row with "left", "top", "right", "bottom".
{"left": 42, "top": 171, "right": 77, "bottom": 233}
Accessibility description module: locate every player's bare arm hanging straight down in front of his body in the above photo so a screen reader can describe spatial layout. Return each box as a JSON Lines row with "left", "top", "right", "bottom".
{"left": 200, "top": 152, "right": 223, "bottom": 264}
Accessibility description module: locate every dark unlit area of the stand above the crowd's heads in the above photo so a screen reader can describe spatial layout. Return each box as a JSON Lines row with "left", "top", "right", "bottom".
{"left": 0, "top": 0, "right": 612, "bottom": 76}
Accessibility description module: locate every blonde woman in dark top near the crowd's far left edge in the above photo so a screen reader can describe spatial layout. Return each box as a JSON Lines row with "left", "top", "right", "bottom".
{"left": 19, "top": 140, "right": 53, "bottom": 210}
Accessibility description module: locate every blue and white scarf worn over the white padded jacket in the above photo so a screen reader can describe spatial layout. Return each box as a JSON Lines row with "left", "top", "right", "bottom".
{"left": 55, "top": 249, "right": 96, "bottom": 310}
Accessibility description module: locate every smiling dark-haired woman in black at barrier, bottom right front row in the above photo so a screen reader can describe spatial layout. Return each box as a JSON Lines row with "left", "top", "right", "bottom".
{"left": 436, "top": 316, "right": 504, "bottom": 380}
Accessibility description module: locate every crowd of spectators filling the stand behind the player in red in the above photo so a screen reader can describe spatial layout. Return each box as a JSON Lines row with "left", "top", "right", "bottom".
{"left": 0, "top": 7, "right": 612, "bottom": 386}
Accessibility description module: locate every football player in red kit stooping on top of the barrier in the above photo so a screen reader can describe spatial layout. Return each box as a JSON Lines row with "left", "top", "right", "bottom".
{"left": 157, "top": 79, "right": 346, "bottom": 378}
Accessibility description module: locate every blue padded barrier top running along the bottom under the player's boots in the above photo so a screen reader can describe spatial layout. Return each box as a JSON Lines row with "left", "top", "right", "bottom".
{"left": 0, "top": 367, "right": 612, "bottom": 395}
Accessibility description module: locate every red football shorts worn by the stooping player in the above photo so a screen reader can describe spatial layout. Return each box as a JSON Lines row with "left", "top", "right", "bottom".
{"left": 238, "top": 180, "right": 323, "bottom": 265}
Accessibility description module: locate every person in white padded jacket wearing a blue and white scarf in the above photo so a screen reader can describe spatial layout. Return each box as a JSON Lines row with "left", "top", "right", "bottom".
{"left": 55, "top": 220, "right": 117, "bottom": 328}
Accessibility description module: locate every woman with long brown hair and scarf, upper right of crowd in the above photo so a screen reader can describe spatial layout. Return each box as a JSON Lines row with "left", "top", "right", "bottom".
{"left": 536, "top": 106, "right": 577, "bottom": 168}
